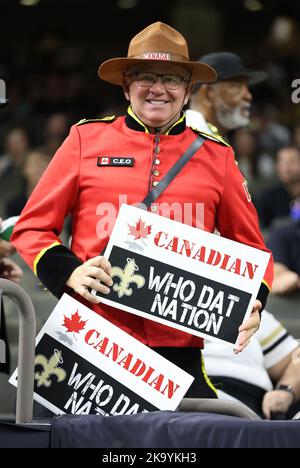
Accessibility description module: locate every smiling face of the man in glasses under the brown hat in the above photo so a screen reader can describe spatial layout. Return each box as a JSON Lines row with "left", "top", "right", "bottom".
{"left": 123, "top": 63, "right": 192, "bottom": 132}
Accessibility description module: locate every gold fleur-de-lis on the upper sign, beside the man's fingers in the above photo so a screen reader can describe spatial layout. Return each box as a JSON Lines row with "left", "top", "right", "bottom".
{"left": 111, "top": 258, "right": 145, "bottom": 297}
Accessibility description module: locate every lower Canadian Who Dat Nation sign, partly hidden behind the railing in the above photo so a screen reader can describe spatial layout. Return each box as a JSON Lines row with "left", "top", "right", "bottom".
{"left": 10, "top": 294, "right": 194, "bottom": 416}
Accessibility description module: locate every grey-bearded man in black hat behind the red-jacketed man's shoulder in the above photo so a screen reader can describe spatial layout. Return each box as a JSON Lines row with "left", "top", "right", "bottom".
{"left": 186, "top": 52, "right": 267, "bottom": 137}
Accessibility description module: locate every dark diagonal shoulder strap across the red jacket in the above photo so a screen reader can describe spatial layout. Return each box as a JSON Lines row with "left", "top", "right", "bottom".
{"left": 141, "top": 136, "right": 205, "bottom": 208}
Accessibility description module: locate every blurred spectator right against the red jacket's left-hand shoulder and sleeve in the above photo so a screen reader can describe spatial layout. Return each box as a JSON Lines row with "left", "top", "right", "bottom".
{"left": 5, "top": 148, "right": 51, "bottom": 218}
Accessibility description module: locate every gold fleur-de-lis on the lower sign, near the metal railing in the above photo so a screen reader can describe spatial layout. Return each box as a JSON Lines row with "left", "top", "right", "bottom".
{"left": 34, "top": 349, "right": 67, "bottom": 387}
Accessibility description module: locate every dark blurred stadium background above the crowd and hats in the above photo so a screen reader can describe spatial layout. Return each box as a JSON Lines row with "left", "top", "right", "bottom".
{"left": 0, "top": 0, "right": 300, "bottom": 144}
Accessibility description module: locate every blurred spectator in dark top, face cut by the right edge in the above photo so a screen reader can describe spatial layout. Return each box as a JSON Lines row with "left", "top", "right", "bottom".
{"left": 255, "top": 146, "right": 300, "bottom": 228}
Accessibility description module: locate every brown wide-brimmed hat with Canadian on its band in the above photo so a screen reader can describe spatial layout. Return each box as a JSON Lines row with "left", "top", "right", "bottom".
{"left": 98, "top": 21, "right": 217, "bottom": 85}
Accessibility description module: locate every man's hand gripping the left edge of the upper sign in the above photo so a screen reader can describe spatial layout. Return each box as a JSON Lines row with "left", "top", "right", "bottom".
{"left": 66, "top": 256, "right": 113, "bottom": 304}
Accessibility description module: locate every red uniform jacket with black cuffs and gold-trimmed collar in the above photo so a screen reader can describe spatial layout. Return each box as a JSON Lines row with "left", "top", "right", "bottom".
{"left": 12, "top": 111, "right": 273, "bottom": 347}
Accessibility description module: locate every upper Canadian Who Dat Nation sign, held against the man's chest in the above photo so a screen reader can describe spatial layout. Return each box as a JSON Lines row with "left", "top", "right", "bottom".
{"left": 93, "top": 204, "right": 270, "bottom": 346}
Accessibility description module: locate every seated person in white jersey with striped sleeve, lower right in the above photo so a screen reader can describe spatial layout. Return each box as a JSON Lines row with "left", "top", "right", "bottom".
{"left": 204, "top": 311, "right": 300, "bottom": 419}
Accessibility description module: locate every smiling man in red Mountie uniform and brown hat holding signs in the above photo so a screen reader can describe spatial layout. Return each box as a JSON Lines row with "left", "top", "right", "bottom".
{"left": 12, "top": 22, "right": 273, "bottom": 397}
